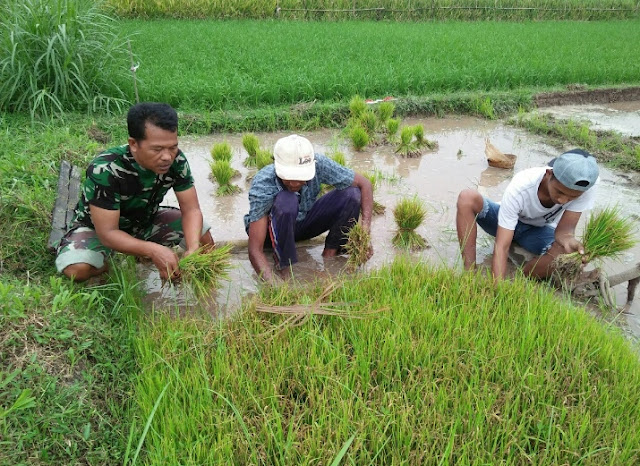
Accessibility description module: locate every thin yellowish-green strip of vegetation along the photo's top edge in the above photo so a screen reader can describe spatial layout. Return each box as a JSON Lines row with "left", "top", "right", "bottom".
{"left": 107, "top": 0, "right": 638, "bottom": 21}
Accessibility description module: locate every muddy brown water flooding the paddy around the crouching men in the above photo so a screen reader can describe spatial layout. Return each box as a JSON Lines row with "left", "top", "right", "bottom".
{"left": 144, "top": 107, "right": 640, "bottom": 342}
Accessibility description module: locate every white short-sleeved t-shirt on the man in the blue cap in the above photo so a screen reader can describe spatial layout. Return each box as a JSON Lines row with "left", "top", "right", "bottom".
{"left": 498, "top": 167, "right": 596, "bottom": 230}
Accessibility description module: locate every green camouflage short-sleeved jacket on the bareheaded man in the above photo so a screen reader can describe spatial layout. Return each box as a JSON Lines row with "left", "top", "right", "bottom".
{"left": 72, "top": 145, "right": 193, "bottom": 234}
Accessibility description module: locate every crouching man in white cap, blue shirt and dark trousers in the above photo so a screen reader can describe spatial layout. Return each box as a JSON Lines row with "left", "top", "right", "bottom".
{"left": 244, "top": 134, "right": 373, "bottom": 282}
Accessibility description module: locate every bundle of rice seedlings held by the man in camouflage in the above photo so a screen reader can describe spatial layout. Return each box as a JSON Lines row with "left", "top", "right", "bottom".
{"left": 178, "top": 244, "right": 232, "bottom": 297}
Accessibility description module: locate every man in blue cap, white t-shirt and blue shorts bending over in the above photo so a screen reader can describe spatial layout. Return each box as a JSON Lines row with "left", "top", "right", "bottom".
{"left": 456, "top": 149, "right": 599, "bottom": 279}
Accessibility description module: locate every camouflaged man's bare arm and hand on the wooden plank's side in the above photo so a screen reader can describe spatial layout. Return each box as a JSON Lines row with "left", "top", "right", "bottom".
{"left": 89, "top": 205, "right": 178, "bottom": 279}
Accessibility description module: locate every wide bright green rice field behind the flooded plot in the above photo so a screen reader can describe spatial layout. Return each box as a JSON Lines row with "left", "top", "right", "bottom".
{"left": 121, "top": 20, "right": 640, "bottom": 112}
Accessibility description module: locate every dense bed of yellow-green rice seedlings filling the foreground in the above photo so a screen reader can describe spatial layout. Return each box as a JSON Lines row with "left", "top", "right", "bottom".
{"left": 132, "top": 259, "right": 640, "bottom": 464}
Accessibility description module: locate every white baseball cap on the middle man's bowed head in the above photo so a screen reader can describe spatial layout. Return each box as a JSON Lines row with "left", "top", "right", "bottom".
{"left": 273, "top": 134, "right": 316, "bottom": 181}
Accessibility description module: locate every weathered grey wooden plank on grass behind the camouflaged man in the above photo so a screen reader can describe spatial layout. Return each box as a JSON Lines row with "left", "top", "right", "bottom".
{"left": 47, "top": 160, "right": 80, "bottom": 251}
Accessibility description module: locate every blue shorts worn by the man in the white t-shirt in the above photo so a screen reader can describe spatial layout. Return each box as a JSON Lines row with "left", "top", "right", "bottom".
{"left": 476, "top": 197, "right": 556, "bottom": 256}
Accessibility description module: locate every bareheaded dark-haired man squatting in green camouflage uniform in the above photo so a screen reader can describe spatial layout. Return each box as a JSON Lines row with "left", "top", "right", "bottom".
{"left": 56, "top": 102, "right": 213, "bottom": 281}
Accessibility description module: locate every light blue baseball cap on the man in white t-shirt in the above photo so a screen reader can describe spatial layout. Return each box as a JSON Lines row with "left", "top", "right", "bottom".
{"left": 549, "top": 149, "right": 600, "bottom": 191}
